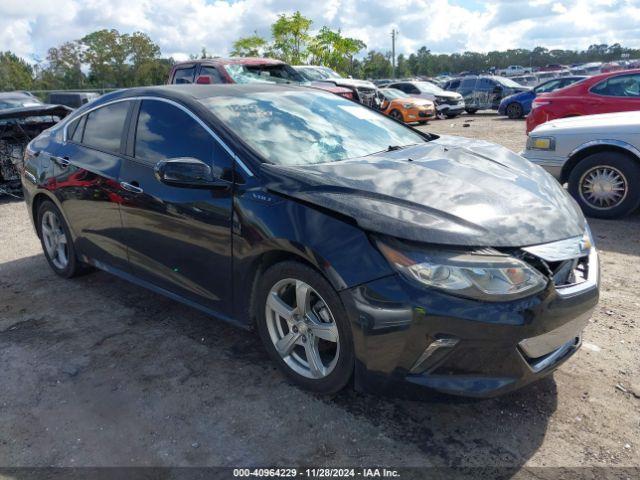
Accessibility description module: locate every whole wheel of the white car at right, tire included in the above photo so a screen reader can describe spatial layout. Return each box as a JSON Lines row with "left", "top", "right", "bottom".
{"left": 569, "top": 151, "right": 640, "bottom": 219}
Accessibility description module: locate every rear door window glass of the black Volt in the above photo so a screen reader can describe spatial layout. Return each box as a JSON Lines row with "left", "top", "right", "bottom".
{"left": 81, "top": 102, "right": 130, "bottom": 153}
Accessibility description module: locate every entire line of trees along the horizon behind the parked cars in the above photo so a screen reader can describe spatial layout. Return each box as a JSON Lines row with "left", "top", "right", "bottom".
{"left": 0, "top": 11, "right": 640, "bottom": 91}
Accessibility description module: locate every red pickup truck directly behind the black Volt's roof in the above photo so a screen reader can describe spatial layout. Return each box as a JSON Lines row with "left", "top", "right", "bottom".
{"left": 167, "top": 57, "right": 353, "bottom": 99}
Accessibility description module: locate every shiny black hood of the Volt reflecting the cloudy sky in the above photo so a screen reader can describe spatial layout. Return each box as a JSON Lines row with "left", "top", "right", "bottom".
{"left": 264, "top": 137, "right": 585, "bottom": 247}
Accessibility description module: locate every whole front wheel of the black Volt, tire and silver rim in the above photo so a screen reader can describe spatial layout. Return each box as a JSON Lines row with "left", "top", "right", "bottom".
{"left": 255, "top": 261, "right": 355, "bottom": 395}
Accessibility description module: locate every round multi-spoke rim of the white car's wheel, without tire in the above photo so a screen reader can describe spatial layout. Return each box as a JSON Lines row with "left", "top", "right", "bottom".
{"left": 579, "top": 165, "right": 628, "bottom": 210}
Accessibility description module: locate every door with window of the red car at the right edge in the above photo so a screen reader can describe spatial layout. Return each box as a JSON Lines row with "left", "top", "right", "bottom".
{"left": 585, "top": 73, "right": 640, "bottom": 114}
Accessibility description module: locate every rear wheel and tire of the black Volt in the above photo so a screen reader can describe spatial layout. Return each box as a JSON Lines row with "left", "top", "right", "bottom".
{"left": 37, "top": 200, "right": 87, "bottom": 278}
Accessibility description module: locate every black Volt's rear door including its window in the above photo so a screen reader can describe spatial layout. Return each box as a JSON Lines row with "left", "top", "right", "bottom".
{"left": 51, "top": 101, "right": 134, "bottom": 270}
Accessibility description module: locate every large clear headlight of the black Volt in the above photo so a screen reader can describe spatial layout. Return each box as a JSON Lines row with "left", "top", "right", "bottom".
{"left": 377, "top": 240, "right": 547, "bottom": 302}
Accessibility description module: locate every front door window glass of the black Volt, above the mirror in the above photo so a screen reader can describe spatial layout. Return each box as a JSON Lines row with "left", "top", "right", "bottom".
{"left": 135, "top": 100, "right": 214, "bottom": 165}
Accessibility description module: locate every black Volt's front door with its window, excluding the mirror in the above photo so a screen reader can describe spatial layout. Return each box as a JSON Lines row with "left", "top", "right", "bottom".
{"left": 120, "top": 99, "right": 233, "bottom": 314}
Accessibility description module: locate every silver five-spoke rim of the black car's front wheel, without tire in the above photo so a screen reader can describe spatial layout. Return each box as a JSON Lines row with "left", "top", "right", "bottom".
{"left": 265, "top": 278, "right": 340, "bottom": 379}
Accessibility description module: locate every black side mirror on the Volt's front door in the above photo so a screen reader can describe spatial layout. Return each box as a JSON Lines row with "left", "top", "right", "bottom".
{"left": 154, "top": 157, "right": 230, "bottom": 188}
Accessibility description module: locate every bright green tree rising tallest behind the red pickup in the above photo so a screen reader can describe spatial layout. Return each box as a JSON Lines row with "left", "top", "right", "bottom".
{"left": 270, "top": 11, "right": 313, "bottom": 65}
